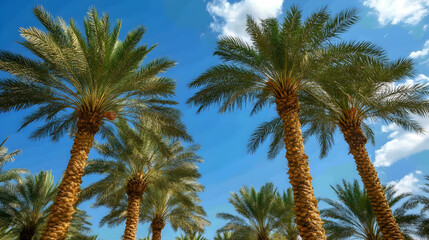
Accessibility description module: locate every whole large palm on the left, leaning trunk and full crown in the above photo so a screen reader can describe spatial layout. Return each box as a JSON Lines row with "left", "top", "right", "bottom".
{"left": 0, "top": 7, "right": 189, "bottom": 240}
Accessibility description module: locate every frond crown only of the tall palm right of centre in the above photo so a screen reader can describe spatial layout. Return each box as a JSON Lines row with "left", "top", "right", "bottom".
{"left": 188, "top": 6, "right": 385, "bottom": 114}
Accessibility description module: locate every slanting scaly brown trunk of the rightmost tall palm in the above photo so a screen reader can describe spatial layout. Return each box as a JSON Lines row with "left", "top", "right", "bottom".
{"left": 341, "top": 126, "right": 404, "bottom": 240}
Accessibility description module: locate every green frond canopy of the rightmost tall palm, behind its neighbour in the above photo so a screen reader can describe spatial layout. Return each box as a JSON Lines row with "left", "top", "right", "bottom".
{"left": 248, "top": 56, "right": 429, "bottom": 159}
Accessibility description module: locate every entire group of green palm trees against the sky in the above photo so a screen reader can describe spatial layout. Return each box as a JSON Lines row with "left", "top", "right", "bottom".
{"left": 0, "top": 3, "right": 429, "bottom": 240}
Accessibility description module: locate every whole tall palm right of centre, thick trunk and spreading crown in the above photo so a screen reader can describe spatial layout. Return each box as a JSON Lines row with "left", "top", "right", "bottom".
{"left": 188, "top": 7, "right": 381, "bottom": 239}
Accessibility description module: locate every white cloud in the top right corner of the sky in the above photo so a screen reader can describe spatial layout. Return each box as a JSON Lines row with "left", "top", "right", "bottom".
{"left": 363, "top": 0, "right": 429, "bottom": 25}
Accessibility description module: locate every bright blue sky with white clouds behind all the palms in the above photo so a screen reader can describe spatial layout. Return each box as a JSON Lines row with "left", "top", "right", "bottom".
{"left": 0, "top": 0, "right": 429, "bottom": 240}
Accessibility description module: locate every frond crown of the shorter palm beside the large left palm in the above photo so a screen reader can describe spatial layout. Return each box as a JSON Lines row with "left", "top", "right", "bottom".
{"left": 79, "top": 123, "right": 202, "bottom": 207}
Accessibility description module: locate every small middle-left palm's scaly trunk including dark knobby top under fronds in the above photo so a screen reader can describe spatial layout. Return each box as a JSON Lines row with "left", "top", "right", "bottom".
{"left": 123, "top": 173, "right": 147, "bottom": 240}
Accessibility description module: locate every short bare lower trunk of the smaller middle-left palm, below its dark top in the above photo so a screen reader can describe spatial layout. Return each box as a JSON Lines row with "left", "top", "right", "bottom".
{"left": 123, "top": 193, "right": 142, "bottom": 240}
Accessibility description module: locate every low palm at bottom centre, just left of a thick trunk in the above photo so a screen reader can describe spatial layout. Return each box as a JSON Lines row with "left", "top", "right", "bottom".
{"left": 217, "top": 183, "right": 280, "bottom": 240}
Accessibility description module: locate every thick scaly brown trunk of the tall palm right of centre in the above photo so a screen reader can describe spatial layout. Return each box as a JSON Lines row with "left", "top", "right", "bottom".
{"left": 276, "top": 93, "right": 326, "bottom": 240}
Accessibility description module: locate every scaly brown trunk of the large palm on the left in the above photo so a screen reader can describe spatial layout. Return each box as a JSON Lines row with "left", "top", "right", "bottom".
{"left": 40, "top": 112, "right": 103, "bottom": 240}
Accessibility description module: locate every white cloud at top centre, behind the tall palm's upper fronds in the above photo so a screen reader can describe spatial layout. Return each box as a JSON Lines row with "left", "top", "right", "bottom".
{"left": 207, "top": 0, "right": 283, "bottom": 41}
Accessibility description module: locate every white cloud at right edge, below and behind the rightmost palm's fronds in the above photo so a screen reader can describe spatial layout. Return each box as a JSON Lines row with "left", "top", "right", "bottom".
{"left": 374, "top": 74, "right": 429, "bottom": 167}
